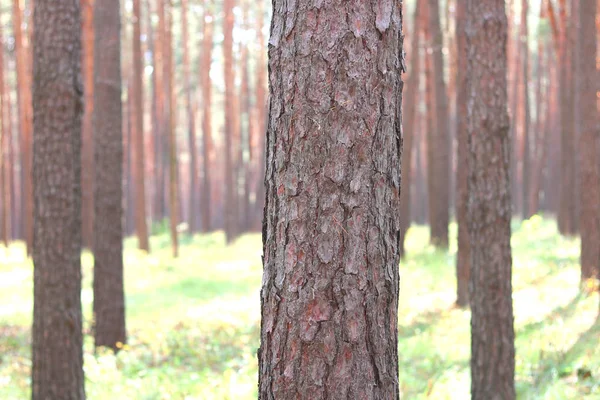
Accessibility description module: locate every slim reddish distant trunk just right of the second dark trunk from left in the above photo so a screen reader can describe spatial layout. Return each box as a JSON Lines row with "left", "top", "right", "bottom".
{"left": 130, "top": 0, "right": 150, "bottom": 251}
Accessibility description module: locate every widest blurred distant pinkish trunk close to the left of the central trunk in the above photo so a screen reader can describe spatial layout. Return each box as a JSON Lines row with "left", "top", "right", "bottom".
{"left": 223, "top": 0, "right": 237, "bottom": 243}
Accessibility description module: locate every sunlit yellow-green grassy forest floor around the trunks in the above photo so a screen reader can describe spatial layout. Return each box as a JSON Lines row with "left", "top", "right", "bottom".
{"left": 0, "top": 217, "right": 600, "bottom": 400}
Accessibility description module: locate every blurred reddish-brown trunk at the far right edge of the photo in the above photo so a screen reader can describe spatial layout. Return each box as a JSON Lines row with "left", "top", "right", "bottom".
{"left": 576, "top": 0, "right": 600, "bottom": 280}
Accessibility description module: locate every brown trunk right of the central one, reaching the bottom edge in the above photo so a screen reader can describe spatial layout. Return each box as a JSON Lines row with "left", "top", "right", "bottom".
{"left": 466, "top": 0, "right": 515, "bottom": 400}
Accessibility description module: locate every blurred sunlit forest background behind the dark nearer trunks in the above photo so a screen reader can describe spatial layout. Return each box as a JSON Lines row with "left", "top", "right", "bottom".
{"left": 0, "top": 0, "right": 600, "bottom": 399}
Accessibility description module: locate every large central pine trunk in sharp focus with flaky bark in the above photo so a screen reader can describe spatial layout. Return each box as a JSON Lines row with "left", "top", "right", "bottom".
{"left": 259, "top": 0, "right": 402, "bottom": 400}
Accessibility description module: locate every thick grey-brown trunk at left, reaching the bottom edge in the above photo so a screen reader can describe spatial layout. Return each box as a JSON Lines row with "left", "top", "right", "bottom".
{"left": 32, "top": 0, "right": 85, "bottom": 400}
